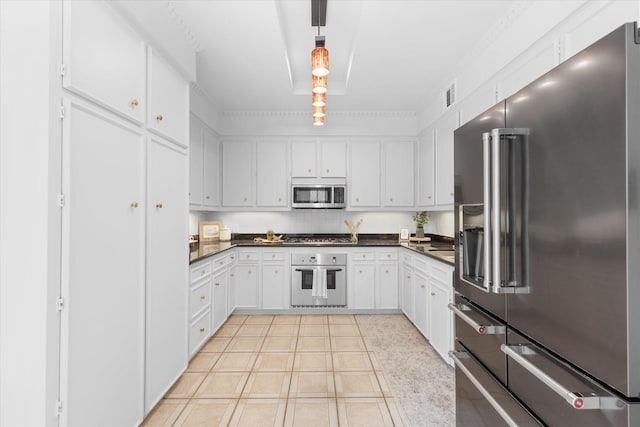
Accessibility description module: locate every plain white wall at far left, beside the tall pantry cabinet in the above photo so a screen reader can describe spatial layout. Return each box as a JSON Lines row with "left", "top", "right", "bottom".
{"left": 0, "top": 0, "right": 62, "bottom": 427}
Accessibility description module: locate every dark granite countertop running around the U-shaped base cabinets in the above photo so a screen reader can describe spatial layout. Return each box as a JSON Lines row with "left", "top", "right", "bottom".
{"left": 189, "top": 234, "right": 454, "bottom": 266}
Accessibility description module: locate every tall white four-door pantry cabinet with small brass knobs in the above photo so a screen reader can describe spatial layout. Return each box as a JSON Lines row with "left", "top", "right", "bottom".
{"left": 60, "top": 1, "right": 189, "bottom": 427}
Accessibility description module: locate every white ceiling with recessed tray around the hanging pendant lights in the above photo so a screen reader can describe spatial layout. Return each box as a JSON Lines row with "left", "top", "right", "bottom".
{"left": 166, "top": 0, "right": 516, "bottom": 111}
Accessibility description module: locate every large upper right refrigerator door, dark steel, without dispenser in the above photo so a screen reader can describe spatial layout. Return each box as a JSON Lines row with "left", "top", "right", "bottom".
{"left": 506, "top": 20, "right": 640, "bottom": 394}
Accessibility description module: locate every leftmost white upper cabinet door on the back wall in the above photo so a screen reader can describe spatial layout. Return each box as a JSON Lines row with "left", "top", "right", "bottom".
{"left": 222, "top": 141, "right": 255, "bottom": 207}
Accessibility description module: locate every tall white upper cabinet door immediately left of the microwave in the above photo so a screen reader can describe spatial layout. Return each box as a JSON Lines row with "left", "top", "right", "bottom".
{"left": 256, "top": 142, "right": 289, "bottom": 207}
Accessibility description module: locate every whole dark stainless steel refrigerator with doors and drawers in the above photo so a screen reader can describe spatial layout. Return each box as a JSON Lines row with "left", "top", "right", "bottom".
{"left": 450, "top": 24, "right": 640, "bottom": 427}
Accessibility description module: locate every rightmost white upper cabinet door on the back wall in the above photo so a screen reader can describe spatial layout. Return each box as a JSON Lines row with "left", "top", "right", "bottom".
{"left": 383, "top": 142, "right": 414, "bottom": 207}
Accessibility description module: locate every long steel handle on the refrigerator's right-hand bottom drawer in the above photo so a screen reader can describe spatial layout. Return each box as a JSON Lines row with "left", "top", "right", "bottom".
{"left": 500, "top": 344, "right": 624, "bottom": 410}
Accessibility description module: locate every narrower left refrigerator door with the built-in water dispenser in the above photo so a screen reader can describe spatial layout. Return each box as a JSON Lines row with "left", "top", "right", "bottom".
{"left": 454, "top": 102, "right": 506, "bottom": 319}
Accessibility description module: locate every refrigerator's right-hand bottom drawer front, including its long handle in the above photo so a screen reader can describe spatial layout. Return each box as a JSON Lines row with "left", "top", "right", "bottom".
{"left": 502, "top": 329, "right": 631, "bottom": 427}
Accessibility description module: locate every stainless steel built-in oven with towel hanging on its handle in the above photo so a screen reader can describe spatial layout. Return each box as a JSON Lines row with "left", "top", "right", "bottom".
{"left": 291, "top": 254, "right": 347, "bottom": 307}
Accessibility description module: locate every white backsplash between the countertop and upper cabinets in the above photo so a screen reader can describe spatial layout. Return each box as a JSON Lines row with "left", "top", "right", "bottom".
{"left": 189, "top": 209, "right": 454, "bottom": 241}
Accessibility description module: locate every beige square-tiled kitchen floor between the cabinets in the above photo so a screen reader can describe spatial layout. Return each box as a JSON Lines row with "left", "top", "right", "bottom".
{"left": 143, "top": 315, "right": 455, "bottom": 427}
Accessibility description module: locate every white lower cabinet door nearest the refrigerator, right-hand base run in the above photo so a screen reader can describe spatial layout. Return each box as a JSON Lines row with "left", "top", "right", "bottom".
{"left": 429, "top": 280, "right": 453, "bottom": 363}
